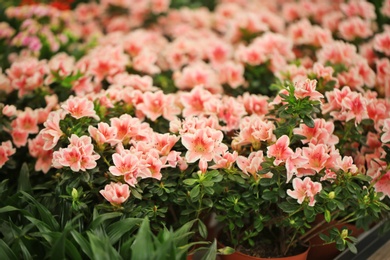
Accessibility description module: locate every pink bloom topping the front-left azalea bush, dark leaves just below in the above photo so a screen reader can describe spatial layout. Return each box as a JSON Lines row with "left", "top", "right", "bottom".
{"left": 61, "top": 97, "right": 99, "bottom": 120}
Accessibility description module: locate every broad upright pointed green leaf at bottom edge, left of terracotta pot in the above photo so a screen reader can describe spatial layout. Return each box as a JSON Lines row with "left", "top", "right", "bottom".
{"left": 131, "top": 217, "right": 154, "bottom": 260}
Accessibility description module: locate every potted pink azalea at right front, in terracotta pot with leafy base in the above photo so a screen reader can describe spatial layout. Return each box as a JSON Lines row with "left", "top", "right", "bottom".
{"left": 215, "top": 79, "right": 389, "bottom": 259}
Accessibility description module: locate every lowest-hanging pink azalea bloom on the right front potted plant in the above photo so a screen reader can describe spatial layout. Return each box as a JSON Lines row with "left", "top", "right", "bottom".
{"left": 287, "top": 177, "right": 322, "bottom": 207}
